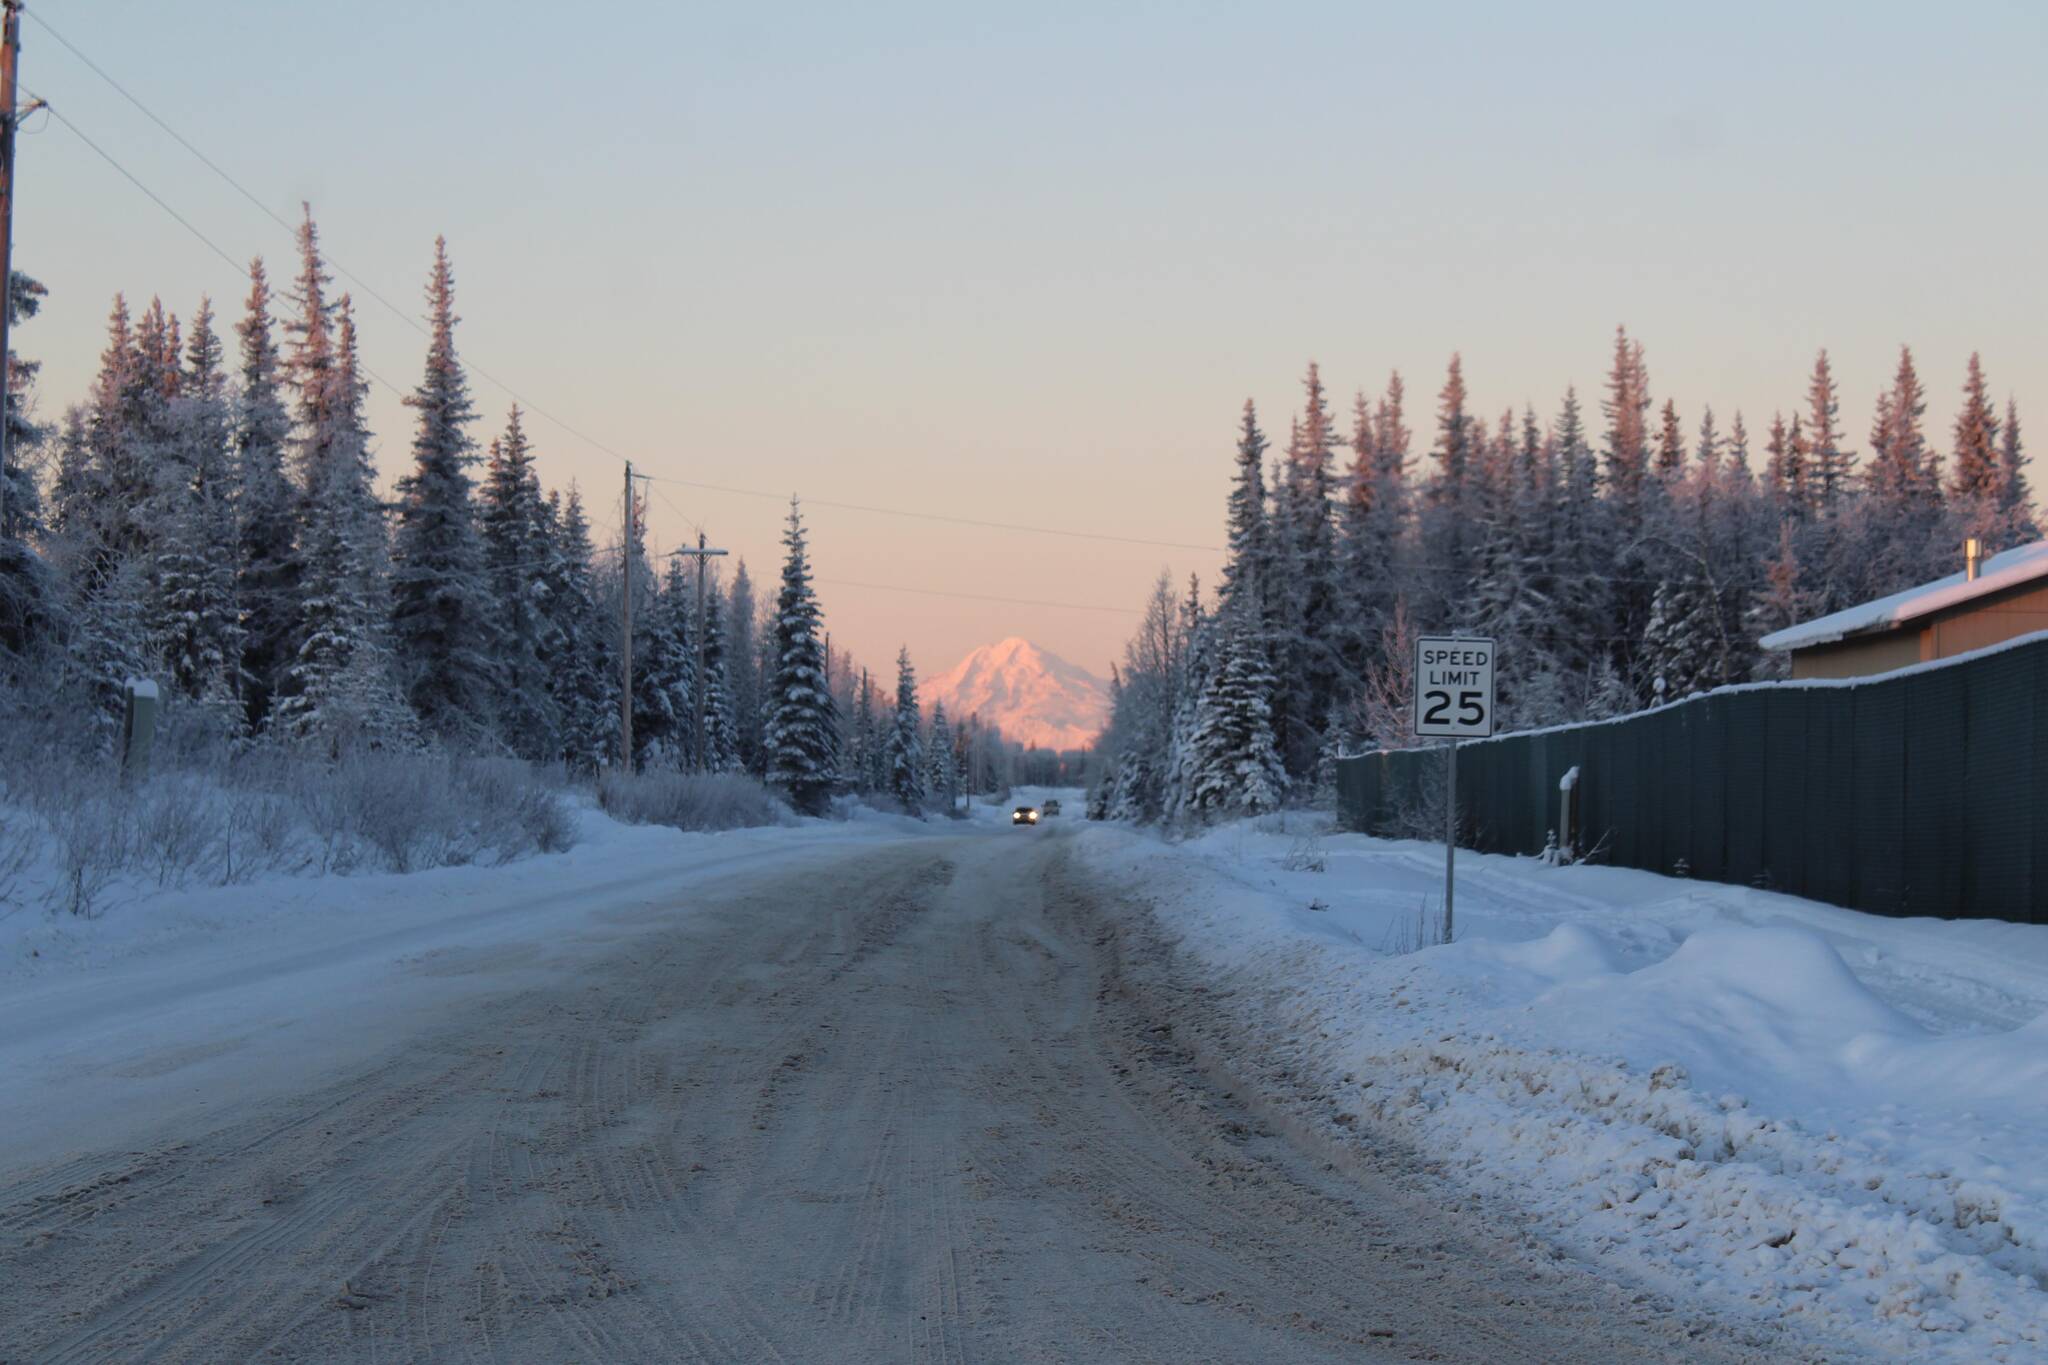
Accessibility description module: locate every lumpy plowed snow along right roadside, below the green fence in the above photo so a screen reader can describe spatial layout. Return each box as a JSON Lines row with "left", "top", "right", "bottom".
{"left": 1083, "top": 817, "right": 2048, "bottom": 1361}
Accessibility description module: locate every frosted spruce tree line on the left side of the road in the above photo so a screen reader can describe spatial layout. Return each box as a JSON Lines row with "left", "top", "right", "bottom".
{"left": 0, "top": 211, "right": 1064, "bottom": 812}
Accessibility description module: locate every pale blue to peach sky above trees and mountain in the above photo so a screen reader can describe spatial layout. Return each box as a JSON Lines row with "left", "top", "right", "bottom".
{"left": 14, "top": 0, "right": 2048, "bottom": 673}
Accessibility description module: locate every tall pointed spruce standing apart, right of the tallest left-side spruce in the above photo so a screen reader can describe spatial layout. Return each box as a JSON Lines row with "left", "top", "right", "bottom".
{"left": 391, "top": 237, "right": 496, "bottom": 741}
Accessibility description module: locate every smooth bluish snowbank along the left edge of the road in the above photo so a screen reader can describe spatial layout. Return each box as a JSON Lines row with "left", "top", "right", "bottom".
{"left": 0, "top": 798, "right": 921, "bottom": 1171}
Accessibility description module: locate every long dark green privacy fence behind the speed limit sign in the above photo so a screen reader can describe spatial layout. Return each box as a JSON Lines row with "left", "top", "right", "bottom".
{"left": 1337, "top": 639, "right": 2048, "bottom": 923}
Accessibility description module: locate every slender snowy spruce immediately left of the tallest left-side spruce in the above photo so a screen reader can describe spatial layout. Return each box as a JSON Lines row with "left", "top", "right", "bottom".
{"left": 231, "top": 258, "right": 301, "bottom": 731}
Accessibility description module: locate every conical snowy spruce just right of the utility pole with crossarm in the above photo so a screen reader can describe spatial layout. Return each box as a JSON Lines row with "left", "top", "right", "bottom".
{"left": 762, "top": 507, "right": 840, "bottom": 814}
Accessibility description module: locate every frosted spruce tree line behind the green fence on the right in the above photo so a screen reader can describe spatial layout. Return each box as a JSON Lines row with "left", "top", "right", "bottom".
{"left": 1092, "top": 327, "right": 2040, "bottom": 823}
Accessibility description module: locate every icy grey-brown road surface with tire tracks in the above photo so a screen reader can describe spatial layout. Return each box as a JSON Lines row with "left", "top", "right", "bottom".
{"left": 0, "top": 829, "right": 1769, "bottom": 1363}
